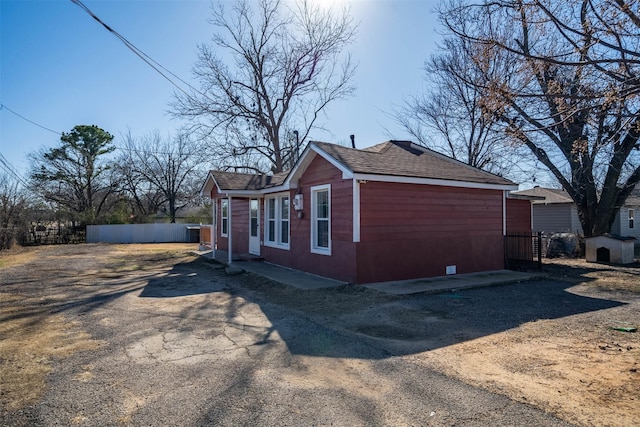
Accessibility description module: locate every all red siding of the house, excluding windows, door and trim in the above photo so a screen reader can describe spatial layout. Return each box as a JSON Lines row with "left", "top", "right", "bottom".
{"left": 212, "top": 162, "right": 520, "bottom": 283}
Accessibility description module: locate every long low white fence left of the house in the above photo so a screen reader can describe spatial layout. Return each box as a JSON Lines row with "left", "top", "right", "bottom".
{"left": 87, "top": 224, "right": 199, "bottom": 243}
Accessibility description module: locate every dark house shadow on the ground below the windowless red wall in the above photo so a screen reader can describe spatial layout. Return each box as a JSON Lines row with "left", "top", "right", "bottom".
{"left": 254, "top": 281, "right": 624, "bottom": 358}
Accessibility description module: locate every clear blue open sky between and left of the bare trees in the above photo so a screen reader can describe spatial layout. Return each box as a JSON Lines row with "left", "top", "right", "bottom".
{"left": 0, "top": 0, "right": 438, "bottom": 175}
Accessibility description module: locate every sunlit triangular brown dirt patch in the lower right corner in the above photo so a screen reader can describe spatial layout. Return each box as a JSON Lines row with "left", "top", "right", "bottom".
{"left": 420, "top": 320, "right": 640, "bottom": 426}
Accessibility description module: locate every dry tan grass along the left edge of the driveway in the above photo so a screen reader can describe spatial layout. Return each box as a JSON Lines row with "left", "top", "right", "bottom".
{"left": 0, "top": 244, "right": 193, "bottom": 410}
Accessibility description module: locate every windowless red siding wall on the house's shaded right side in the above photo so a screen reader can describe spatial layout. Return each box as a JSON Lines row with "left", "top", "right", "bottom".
{"left": 357, "top": 182, "right": 504, "bottom": 283}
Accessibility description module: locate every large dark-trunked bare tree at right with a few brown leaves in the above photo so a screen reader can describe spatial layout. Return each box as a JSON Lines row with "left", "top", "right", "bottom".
{"left": 440, "top": 0, "right": 640, "bottom": 236}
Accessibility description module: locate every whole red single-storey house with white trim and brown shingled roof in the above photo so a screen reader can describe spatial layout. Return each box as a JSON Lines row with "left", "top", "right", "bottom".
{"left": 202, "top": 141, "right": 531, "bottom": 283}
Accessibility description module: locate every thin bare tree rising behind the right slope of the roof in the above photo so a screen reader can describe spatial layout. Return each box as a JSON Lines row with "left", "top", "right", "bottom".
{"left": 394, "top": 37, "right": 516, "bottom": 176}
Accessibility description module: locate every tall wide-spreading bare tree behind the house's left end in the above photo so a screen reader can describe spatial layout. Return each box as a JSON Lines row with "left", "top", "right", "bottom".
{"left": 172, "top": 0, "right": 355, "bottom": 172}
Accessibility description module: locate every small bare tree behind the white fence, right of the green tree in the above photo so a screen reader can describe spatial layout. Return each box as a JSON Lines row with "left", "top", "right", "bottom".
{"left": 118, "top": 132, "right": 205, "bottom": 223}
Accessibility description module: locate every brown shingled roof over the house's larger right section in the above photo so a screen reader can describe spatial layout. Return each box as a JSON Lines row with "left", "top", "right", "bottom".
{"left": 312, "top": 141, "right": 515, "bottom": 185}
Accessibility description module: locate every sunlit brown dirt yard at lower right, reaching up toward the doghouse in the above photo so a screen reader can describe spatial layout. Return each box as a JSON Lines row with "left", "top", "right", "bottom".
{"left": 415, "top": 259, "right": 640, "bottom": 426}
